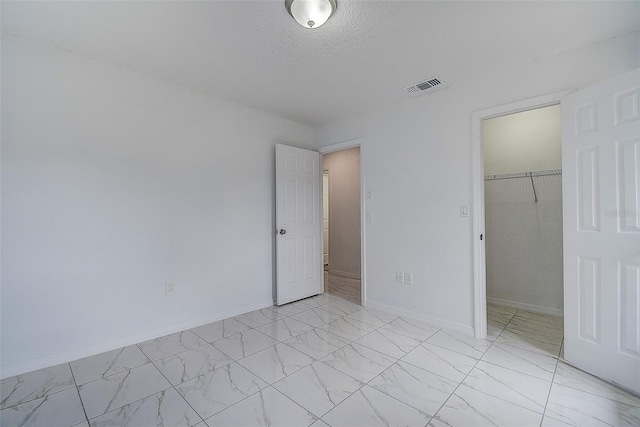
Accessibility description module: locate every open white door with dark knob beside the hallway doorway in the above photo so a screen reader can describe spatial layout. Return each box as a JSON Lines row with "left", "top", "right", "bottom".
{"left": 276, "top": 144, "right": 324, "bottom": 305}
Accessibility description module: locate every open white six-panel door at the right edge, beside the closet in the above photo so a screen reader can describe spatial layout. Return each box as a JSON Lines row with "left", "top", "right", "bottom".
{"left": 562, "top": 70, "right": 640, "bottom": 393}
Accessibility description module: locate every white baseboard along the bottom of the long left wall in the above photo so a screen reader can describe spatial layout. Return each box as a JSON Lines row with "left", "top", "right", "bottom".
{"left": 0, "top": 301, "right": 273, "bottom": 379}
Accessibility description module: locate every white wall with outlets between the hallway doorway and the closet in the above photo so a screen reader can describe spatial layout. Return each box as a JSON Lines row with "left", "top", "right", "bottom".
{"left": 316, "top": 35, "right": 640, "bottom": 332}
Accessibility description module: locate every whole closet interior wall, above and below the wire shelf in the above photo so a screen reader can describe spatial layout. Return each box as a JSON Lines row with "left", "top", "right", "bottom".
{"left": 483, "top": 105, "right": 563, "bottom": 314}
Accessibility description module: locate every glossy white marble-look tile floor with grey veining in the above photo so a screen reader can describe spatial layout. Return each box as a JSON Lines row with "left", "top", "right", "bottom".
{"left": 0, "top": 277, "right": 640, "bottom": 427}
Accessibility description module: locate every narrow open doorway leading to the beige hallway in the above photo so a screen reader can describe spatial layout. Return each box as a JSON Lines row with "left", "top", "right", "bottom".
{"left": 320, "top": 143, "right": 364, "bottom": 305}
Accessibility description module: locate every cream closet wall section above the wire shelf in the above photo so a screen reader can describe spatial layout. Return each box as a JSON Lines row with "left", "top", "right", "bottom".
{"left": 482, "top": 105, "right": 562, "bottom": 175}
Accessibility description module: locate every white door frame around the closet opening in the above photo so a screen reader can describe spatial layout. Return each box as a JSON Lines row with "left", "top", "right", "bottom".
{"left": 471, "top": 90, "right": 575, "bottom": 338}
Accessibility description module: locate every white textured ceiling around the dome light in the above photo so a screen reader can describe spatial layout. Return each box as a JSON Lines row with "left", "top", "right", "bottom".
{"left": 1, "top": 0, "right": 640, "bottom": 125}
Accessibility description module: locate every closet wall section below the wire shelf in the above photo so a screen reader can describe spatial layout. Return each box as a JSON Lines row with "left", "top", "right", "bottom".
{"left": 485, "top": 176, "right": 563, "bottom": 315}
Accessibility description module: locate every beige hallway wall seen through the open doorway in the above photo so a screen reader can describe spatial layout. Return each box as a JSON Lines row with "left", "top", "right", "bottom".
{"left": 322, "top": 147, "right": 360, "bottom": 278}
